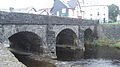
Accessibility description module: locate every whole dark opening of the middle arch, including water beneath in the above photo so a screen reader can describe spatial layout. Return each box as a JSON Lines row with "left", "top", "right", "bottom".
{"left": 56, "top": 29, "right": 81, "bottom": 61}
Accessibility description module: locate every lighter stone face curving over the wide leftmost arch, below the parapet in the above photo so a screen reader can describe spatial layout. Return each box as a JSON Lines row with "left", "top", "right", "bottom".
{"left": 2, "top": 25, "right": 46, "bottom": 45}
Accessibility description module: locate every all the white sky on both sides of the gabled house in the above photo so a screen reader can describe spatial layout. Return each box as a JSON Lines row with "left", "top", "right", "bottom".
{"left": 0, "top": 0, "right": 120, "bottom": 9}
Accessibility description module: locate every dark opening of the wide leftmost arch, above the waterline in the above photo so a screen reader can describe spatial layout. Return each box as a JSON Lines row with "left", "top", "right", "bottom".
{"left": 8, "top": 31, "right": 43, "bottom": 53}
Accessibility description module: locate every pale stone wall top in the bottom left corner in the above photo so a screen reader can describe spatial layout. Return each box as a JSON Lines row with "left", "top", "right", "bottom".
{"left": 0, "top": 44, "right": 26, "bottom": 67}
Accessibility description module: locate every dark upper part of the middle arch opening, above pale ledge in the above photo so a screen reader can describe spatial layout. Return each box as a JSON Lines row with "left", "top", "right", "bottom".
{"left": 56, "top": 28, "right": 77, "bottom": 46}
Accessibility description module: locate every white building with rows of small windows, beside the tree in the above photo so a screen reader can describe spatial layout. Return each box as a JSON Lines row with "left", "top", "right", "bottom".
{"left": 81, "top": 5, "right": 109, "bottom": 23}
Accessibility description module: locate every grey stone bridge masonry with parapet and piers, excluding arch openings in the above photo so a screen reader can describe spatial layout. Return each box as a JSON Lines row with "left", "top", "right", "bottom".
{"left": 0, "top": 12, "right": 96, "bottom": 56}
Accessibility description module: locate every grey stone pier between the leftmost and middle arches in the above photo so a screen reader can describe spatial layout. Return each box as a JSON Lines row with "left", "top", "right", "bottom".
{"left": 46, "top": 25, "right": 57, "bottom": 58}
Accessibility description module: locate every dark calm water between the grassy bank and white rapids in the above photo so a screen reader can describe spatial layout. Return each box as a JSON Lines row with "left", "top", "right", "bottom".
{"left": 84, "top": 44, "right": 120, "bottom": 60}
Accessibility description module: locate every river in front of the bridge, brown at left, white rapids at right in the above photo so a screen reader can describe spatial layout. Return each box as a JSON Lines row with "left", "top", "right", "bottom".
{"left": 11, "top": 45, "right": 120, "bottom": 67}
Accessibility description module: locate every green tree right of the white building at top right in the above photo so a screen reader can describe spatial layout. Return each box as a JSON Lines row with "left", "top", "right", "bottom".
{"left": 108, "top": 4, "right": 120, "bottom": 22}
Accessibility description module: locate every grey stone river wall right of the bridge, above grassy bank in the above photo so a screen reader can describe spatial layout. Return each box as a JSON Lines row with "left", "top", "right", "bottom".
{"left": 97, "top": 24, "right": 120, "bottom": 39}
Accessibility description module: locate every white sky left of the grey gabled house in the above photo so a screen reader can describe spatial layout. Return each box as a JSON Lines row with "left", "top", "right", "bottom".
{"left": 0, "top": 0, "right": 54, "bottom": 8}
